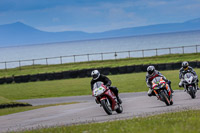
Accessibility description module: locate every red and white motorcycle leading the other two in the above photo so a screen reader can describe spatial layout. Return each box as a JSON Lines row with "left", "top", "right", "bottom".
{"left": 93, "top": 81, "right": 123, "bottom": 115}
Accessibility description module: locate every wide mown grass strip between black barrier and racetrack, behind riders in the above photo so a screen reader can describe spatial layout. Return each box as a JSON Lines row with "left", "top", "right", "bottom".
{"left": 0, "top": 69, "right": 197, "bottom": 100}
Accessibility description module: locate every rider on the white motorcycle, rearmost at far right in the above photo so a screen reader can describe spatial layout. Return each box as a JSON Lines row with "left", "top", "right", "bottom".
{"left": 179, "top": 61, "right": 199, "bottom": 91}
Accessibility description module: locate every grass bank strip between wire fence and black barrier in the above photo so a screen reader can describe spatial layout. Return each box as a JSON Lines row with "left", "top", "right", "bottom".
{"left": 0, "top": 53, "right": 200, "bottom": 77}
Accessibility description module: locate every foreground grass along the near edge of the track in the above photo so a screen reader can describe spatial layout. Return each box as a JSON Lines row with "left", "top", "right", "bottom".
{"left": 18, "top": 110, "right": 200, "bottom": 133}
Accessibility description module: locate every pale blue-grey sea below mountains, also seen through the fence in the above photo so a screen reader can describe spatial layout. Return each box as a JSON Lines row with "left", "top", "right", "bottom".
{"left": 0, "top": 31, "right": 200, "bottom": 68}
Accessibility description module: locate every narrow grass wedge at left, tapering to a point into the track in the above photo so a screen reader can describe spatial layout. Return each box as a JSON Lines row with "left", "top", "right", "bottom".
{"left": 0, "top": 102, "right": 77, "bottom": 116}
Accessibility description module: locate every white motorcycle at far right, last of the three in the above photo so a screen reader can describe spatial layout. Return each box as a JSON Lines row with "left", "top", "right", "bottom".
{"left": 183, "top": 73, "right": 197, "bottom": 99}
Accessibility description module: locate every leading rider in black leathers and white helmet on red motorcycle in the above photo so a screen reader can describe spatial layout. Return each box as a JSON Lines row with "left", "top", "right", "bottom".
{"left": 90, "top": 70, "right": 122, "bottom": 104}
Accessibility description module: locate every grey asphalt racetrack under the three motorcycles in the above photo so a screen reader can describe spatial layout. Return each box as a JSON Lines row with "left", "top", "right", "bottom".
{"left": 0, "top": 90, "right": 200, "bottom": 132}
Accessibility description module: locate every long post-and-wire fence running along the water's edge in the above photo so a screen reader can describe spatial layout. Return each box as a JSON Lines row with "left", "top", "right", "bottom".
{"left": 0, "top": 45, "right": 200, "bottom": 69}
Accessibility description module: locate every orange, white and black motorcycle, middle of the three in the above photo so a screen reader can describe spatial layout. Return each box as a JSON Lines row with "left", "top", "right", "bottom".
{"left": 152, "top": 77, "right": 173, "bottom": 106}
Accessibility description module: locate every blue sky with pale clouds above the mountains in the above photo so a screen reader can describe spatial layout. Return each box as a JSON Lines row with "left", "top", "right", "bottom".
{"left": 0, "top": 0, "right": 200, "bottom": 32}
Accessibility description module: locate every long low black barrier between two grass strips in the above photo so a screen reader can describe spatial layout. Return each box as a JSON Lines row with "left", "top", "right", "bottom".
{"left": 0, "top": 61, "right": 200, "bottom": 84}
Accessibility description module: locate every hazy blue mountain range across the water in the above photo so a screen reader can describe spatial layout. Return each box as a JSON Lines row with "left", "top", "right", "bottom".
{"left": 0, "top": 18, "right": 200, "bottom": 47}
